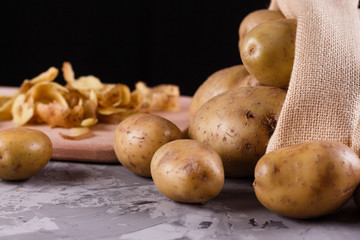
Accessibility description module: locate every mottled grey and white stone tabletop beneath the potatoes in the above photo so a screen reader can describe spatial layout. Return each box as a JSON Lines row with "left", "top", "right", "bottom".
{"left": 0, "top": 161, "right": 360, "bottom": 240}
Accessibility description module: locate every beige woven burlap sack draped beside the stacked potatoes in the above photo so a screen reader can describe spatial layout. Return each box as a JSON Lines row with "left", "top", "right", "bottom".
{"left": 267, "top": 0, "right": 360, "bottom": 155}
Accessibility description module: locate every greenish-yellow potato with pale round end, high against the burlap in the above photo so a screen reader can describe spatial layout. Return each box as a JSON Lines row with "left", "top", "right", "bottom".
{"left": 240, "top": 19, "right": 297, "bottom": 89}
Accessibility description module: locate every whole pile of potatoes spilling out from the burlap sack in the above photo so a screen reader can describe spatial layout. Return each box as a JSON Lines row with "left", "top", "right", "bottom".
{"left": 114, "top": 9, "right": 360, "bottom": 219}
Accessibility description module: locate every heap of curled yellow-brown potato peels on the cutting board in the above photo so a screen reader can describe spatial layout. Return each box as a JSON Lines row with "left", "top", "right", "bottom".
{"left": 0, "top": 62, "right": 180, "bottom": 140}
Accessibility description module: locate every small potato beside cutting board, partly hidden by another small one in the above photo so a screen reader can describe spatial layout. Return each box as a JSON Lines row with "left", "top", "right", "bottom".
{"left": 114, "top": 113, "right": 183, "bottom": 177}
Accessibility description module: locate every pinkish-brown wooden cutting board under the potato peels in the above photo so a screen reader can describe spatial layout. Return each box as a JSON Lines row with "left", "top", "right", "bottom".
{"left": 0, "top": 87, "right": 191, "bottom": 163}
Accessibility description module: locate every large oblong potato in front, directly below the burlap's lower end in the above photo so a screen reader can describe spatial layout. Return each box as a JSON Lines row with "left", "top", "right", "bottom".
{"left": 253, "top": 141, "right": 360, "bottom": 219}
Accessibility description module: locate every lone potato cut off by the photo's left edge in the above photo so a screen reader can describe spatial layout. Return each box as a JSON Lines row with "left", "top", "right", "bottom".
{"left": 0, "top": 127, "right": 53, "bottom": 180}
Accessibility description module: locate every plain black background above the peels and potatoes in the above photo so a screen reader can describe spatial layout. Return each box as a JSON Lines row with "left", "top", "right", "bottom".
{"left": 0, "top": 0, "right": 270, "bottom": 95}
